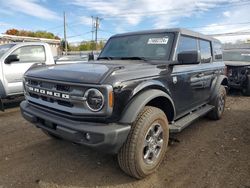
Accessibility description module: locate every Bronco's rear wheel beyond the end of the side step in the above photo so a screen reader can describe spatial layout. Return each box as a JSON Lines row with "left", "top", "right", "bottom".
{"left": 207, "top": 85, "right": 227, "bottom": 120}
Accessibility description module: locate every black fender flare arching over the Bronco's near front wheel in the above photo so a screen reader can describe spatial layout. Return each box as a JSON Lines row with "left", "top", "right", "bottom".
{"left": 119, "top": 89, "right": 176, "bottom": 124}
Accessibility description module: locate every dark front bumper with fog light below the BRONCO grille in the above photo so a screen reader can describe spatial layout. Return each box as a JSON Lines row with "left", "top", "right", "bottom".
{"left": 20, "top": 101, "right": 130, "bottom": 153}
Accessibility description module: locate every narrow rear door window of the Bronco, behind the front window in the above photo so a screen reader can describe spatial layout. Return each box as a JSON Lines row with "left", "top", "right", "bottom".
{"left": 199, "top": 40, "right": 212, "bottom": 63}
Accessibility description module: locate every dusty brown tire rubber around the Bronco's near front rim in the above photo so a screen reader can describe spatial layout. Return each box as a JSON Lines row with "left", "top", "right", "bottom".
{"left": 118, "top": 106, "right": 169, "bottom": 179}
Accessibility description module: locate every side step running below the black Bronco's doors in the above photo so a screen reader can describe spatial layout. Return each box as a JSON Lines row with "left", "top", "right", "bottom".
{"left": 169, "top": 104, "right": 214, "bottom": 133}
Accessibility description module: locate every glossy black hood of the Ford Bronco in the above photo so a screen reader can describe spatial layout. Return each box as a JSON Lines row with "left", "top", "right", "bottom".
{"left": 25, "top": 60, "right": 170, "bottom": 84}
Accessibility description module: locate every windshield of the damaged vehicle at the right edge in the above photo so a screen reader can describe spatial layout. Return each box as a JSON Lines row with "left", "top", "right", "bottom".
{"left": 223, "top": 51, "right": 250, "bottom": 62}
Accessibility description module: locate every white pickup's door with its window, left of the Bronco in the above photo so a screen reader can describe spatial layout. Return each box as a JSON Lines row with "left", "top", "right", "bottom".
{"left": 3, "top": 45, "right": 46, "bottom": 95}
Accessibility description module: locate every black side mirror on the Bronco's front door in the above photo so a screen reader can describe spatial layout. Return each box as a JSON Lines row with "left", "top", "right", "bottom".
{"left": 177, "top": 51, "right": 201, "bottom": 64}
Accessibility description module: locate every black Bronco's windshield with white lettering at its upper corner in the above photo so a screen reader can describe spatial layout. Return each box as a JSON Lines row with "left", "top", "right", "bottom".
{"left": 98, "top": 33, "right": 174, "bottom": 60}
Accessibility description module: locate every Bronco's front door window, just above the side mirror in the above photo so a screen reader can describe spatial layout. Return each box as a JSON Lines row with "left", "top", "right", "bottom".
{"left": 177, "top": 36, "right": 197, "bottom": 54}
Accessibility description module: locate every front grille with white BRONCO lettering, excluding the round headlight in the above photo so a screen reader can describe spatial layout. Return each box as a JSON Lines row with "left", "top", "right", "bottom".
{"left": 24, "top": 77, "right": 112, "bottom": 118}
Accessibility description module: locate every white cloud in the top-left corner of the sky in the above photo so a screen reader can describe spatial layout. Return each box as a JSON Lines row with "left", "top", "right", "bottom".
{"left": 0, "top": 0, "right": 60, "bottom": 20}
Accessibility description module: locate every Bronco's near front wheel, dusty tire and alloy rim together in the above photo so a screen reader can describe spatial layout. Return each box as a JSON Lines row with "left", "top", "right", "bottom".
{"left": 118, "top": 106, "right": 169, "bottom": 179}
